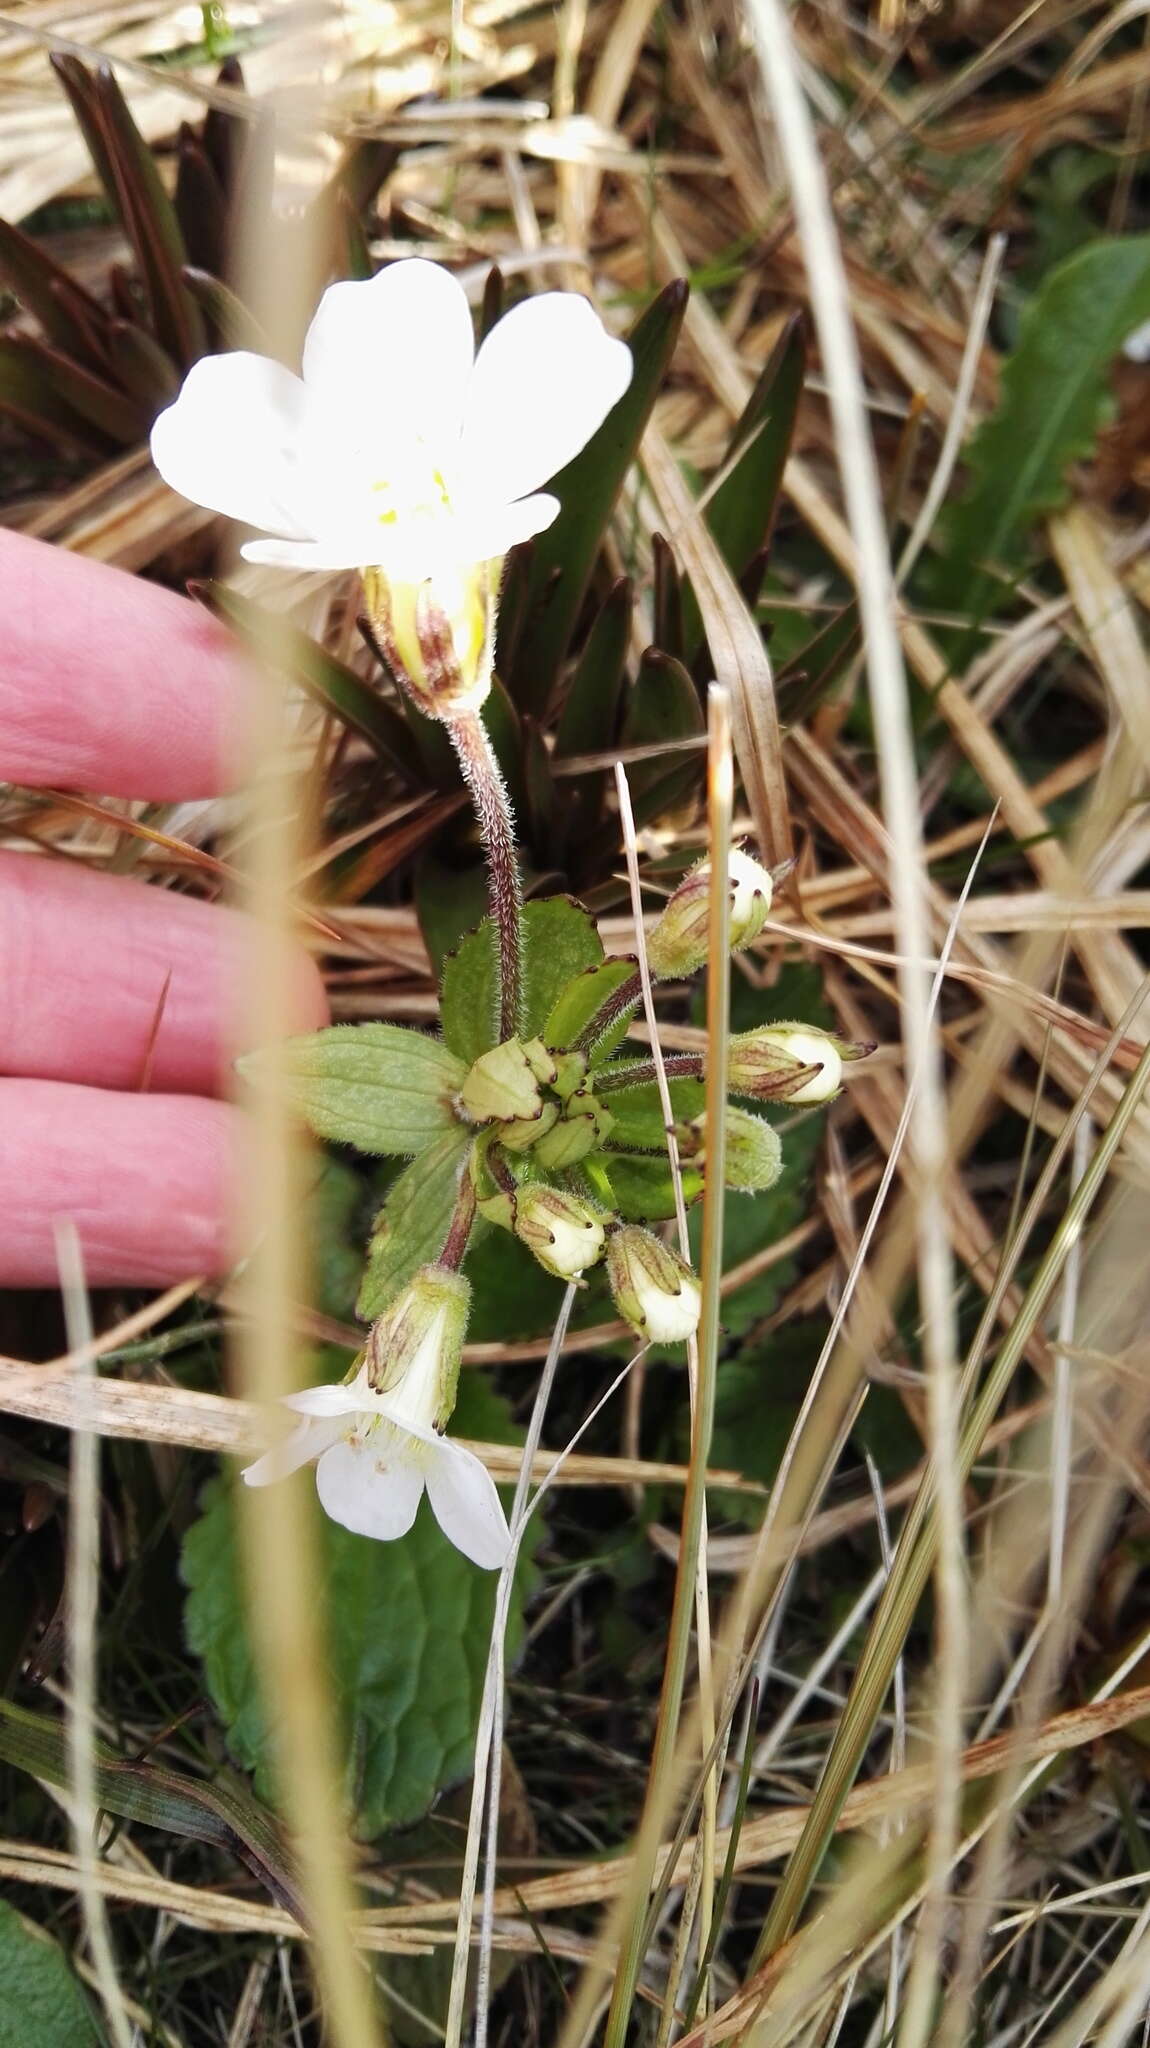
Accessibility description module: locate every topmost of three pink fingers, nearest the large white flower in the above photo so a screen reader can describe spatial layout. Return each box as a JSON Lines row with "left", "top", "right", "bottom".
{"left": 0, "top": 532, "right": 244, "bottom": 803}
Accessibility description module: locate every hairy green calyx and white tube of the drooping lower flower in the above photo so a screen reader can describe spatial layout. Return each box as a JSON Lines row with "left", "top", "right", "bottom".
{"left": 364, "top": 1266, "right": 471, "bottom": 1432}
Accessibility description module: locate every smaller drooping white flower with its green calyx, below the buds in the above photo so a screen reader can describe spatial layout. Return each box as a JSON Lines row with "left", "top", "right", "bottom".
{"left": 244, "top": 1268, "right": 510, "bottom": 1571}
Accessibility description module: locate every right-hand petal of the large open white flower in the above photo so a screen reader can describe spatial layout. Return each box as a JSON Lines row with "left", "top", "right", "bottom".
{"left": 460, "top": 291, "right": 632, "bottom": 504}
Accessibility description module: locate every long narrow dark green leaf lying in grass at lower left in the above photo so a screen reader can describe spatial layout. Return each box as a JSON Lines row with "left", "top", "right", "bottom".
{"left": 0, "top": 1700, "right": 303, "bottom": 1916}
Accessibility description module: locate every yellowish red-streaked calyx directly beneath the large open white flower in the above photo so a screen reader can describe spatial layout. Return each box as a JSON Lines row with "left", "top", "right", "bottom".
{"left": 362, "top": 563, "right": 495, "bottom": 719}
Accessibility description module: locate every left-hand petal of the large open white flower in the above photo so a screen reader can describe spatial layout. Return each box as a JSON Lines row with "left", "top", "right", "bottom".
{"left": 151, "top": 348, "right": 315, "bottom": 541}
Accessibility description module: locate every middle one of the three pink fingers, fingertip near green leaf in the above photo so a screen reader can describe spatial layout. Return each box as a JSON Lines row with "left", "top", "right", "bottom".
{"left": 0, "top": 852, "right": 327, "bottom": 1096}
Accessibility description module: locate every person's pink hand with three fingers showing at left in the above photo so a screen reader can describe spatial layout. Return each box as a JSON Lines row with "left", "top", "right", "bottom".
{"left": 0, "top": 532, "right": 327, "bottom": 1286}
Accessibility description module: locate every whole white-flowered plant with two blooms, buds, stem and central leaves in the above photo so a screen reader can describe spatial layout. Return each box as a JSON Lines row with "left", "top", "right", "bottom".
{"left": 151, "top": 260, "right": 866, "bottom": 1569}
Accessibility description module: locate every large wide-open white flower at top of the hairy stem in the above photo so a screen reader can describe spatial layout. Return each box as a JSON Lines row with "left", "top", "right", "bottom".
{"left": 151, "top": 258, "right": 632, "bottom": 696}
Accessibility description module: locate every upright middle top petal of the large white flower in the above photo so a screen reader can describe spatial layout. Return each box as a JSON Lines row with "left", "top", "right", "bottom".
{"left": 303, "top": 256, "right": 475, "bottom": 451}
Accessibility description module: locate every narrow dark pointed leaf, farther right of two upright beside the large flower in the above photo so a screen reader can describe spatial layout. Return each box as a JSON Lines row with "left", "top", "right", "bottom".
{"left": 679, "top": 313, "right": 806, "bottom": 662}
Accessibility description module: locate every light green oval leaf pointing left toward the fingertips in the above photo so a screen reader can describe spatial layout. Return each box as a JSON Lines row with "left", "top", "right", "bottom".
{"left": 237, "top": 1024, "right": 467, "bottom": 1153}
